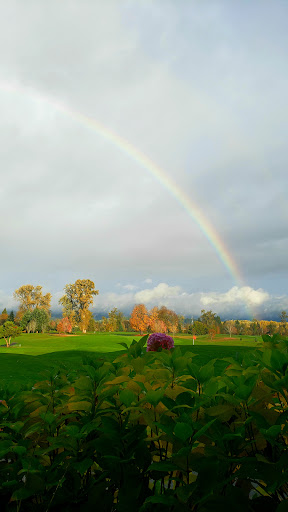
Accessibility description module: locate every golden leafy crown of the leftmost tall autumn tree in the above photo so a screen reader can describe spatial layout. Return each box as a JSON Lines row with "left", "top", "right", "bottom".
{"left": 13, "top": 284, "right": 51, "bottom": 312}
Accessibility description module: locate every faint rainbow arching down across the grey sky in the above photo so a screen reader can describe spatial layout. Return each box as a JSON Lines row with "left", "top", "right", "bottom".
{"left": 0, "top": 80, "right": 244, "bottom": 286}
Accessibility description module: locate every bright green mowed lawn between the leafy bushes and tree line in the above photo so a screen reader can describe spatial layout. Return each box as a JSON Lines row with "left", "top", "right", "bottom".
{"left": 0, "top": 333, "right": 261, "bottom": 389}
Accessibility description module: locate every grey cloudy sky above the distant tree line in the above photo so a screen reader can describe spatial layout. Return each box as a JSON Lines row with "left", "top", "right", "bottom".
{"left": 0, "top": 0, "right": 288, "bottom": 318}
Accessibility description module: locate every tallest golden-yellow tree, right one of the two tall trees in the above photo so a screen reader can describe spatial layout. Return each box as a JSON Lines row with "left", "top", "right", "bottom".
{"left": 59, "top": 279, "right": 99, "bottom": 332}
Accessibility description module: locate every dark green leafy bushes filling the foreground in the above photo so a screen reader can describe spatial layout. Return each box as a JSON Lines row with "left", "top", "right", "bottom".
{"left": 0, "top": 336, "right": 288, "bottom": 512}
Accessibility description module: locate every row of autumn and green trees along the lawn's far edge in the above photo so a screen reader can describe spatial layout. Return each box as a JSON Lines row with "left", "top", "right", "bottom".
{"left": 0, "top": 279, "right": 288, "bottom": 343}
